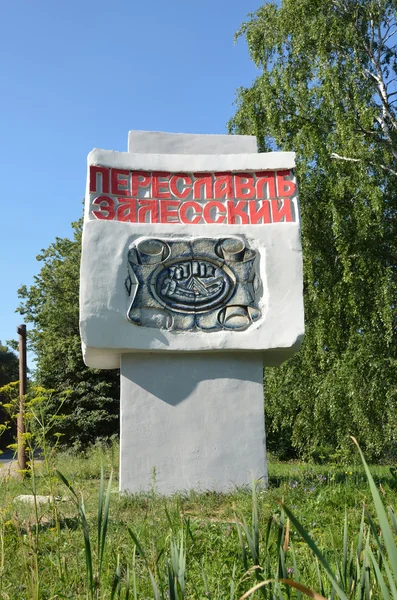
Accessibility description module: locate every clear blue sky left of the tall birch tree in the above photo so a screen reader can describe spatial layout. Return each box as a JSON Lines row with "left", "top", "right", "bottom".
{"left": 0, "top": 0, "right": 262, "bottom": 366}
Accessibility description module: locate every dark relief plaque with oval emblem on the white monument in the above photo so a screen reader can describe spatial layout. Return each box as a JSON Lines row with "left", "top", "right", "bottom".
{"left": 125, "top": 237, "right": 260, "bottom": 332}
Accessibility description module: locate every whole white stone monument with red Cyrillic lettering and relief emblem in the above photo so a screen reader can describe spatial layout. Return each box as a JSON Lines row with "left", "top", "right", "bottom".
{"left": 80, "top": 131, "right": 304, "bottom": 494}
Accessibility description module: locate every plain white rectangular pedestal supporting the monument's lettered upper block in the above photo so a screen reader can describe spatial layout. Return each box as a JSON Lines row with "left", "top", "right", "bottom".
{"left": 120, "top": 352, "right": 267, "bottom": 495}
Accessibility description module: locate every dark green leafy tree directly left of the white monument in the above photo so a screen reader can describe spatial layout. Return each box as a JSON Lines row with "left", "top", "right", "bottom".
{"left": 18, "top": 220, "right": 120, "bottom": 446}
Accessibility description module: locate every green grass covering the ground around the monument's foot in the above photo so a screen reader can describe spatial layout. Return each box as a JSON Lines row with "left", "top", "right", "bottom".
{"left": 0, "top": 446, "right": 397, "bottom": 600}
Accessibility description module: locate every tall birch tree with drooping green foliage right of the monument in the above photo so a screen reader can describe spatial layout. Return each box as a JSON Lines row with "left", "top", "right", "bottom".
{"left": 229, "top": 0, "right": 397, "bottom": 459}
